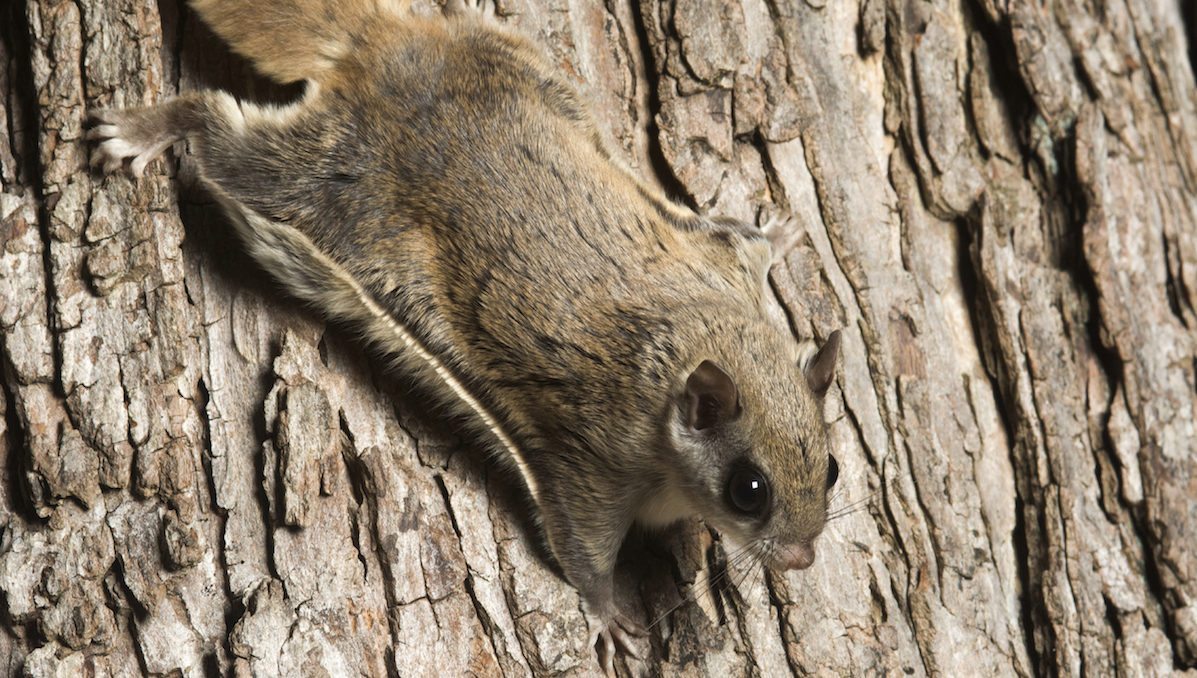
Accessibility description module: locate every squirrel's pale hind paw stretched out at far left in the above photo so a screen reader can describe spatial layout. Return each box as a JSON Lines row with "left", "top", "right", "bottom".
{"left": 87, "top": 110, "right": 180, "bottom": 176}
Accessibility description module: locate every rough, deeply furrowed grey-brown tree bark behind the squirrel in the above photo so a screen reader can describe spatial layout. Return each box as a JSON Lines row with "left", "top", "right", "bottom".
{"left": 0, "top": 0, "right": 1197, "bottom": 676}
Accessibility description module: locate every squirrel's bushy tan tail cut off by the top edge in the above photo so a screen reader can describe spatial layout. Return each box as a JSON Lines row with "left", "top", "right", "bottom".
{"left": 190, "top": 0, "right": 411, "bottom": 83}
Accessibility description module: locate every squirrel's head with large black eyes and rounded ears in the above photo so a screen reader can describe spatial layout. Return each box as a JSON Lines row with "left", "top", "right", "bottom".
{"left": 667, "top": 327, "right": 840, "bottom": 570}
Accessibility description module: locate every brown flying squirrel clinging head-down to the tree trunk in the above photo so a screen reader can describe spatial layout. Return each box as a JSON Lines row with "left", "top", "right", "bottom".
{"left": 89, "top": 0, "right": 839, "bottom": 671}
